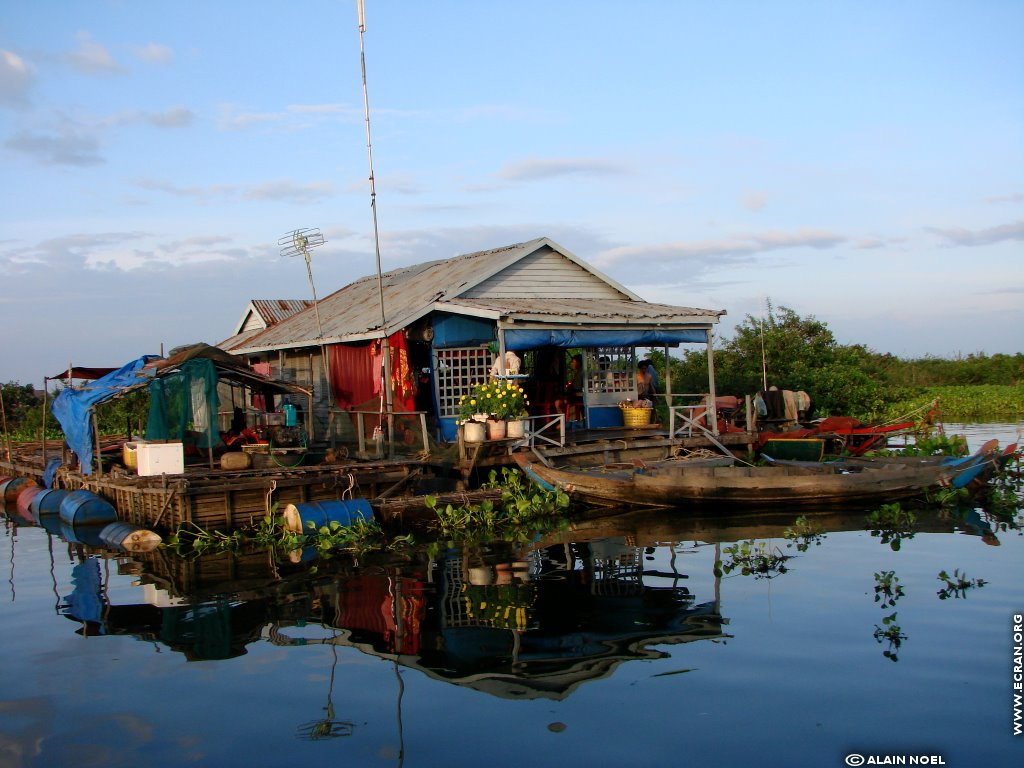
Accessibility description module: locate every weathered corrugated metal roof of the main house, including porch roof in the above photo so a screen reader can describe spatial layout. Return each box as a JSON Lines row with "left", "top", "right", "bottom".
{"left": 230, "top": 238, "right": 724, "bottom": 353}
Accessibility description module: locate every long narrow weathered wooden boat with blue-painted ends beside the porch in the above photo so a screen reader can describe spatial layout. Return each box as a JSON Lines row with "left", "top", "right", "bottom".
{"left": 514, "top": 444, "right": 998, "bottom": 508}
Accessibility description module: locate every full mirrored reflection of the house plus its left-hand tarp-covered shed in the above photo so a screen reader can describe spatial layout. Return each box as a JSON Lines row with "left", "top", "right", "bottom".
{"left": 60, "top": 540, "right": 723, "bottom": 698}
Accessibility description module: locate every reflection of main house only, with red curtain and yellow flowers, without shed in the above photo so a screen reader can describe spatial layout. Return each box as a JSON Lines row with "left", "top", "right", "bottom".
{"left": 279, "top": 543, "right": 725, "bottom": 698}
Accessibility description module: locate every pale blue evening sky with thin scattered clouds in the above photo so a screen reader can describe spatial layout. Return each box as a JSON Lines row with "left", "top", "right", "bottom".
{"left": 0, "top": 0, "right": 1024, "bottom": 383}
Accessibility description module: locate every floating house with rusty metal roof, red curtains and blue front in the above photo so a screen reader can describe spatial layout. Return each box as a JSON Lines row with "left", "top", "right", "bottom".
{"left": 219, "top": 238, "right": 725, "bottom": 445}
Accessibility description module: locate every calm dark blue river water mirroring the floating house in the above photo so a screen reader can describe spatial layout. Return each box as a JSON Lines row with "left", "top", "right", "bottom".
{"left": 0, "top": 425, "right": 1024, "bottom": 768}
